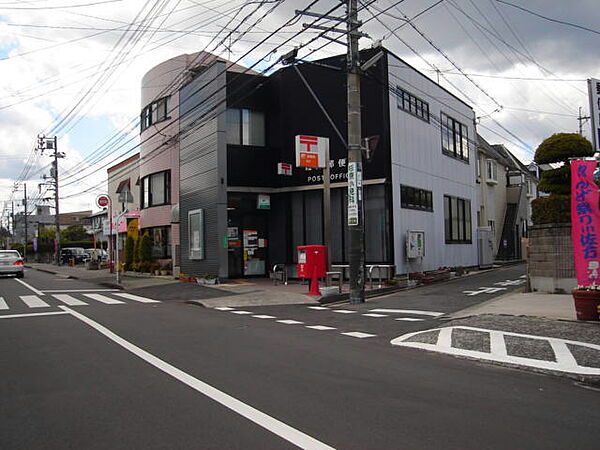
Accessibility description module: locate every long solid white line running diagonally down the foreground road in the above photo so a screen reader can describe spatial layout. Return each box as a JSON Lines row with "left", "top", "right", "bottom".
{"left": 61, "top": 306, "right": 333, "bottom": 450}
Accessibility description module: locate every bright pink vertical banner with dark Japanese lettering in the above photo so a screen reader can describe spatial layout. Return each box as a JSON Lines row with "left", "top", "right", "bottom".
{"left": 571, "top": 161, "right": 600, "bottom": 286}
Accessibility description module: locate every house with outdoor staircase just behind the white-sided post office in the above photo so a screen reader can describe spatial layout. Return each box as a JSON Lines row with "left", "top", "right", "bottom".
{"left": 477, "top": 135, "right": 538, "bottom": 261}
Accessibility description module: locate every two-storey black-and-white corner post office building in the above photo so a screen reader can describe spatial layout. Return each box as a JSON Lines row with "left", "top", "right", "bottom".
{"left": 179, "top": 49, "right": 478, "bottom": 278}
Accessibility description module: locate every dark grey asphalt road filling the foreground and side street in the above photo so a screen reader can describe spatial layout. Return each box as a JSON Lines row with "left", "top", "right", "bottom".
{"left": 0, "top": 267, "right": 600, "bottom": 449}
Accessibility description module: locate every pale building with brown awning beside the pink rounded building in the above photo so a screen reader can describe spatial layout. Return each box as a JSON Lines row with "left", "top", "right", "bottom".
{"left": 104, "top": 153, "right": 140, "bottom": 259}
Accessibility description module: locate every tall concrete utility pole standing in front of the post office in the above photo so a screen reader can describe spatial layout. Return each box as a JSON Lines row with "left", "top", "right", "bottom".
{"left": 347, "top": 0, "right": 365, "bottom": 304}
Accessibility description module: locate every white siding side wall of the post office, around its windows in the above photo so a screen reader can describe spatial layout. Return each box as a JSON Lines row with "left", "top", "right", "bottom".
{"left": 388, "top": 54, "right": 479, "bottom": 273}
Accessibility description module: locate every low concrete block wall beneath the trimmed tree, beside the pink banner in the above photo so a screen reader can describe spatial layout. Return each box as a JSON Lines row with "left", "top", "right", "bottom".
{"left": 527, "top": 223, "right": 577, "bottom": 293}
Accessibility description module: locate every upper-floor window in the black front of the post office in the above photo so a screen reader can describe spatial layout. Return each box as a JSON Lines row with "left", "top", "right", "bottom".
{"left": 225, "top": 109, "right": 265, "bottom": 147}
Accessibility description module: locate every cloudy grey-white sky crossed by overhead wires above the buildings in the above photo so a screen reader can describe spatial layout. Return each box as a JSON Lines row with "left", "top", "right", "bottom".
{"left": 0, "top": 0, "right": 600, "bottom": 225}
